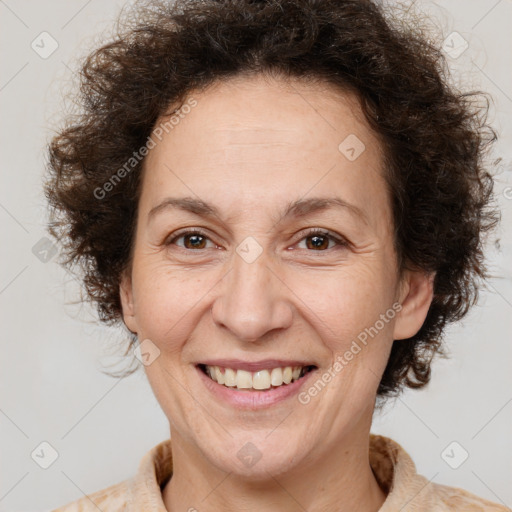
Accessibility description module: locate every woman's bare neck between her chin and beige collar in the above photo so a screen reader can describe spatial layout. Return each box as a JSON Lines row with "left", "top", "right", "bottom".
{"left": 163, "top": 431, "right": 386, "bottom": 512}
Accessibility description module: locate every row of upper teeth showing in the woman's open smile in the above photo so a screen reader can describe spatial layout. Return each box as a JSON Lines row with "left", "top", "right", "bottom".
{"left": 198, "top": 364, "right": 316, "bottom": 391}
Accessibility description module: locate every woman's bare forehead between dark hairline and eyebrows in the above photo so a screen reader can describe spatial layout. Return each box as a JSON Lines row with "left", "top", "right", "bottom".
{"left": 141, "top": 75, "right": 387, "bottom": 230}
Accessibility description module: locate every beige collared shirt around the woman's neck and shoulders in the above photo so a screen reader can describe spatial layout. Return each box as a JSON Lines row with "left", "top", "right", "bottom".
{"left": 52, "top": 435, "right": 510, "bottom": 512}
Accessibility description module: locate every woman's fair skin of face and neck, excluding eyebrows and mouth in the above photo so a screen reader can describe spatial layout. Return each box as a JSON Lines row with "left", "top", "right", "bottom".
{"left": 120, "top": 75, "right": 433, "bottom": 512}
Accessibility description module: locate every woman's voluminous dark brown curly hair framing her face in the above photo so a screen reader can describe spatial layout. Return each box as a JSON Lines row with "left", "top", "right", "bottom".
{"left": 45, "top": 0, "right": 499, "bottom": 397}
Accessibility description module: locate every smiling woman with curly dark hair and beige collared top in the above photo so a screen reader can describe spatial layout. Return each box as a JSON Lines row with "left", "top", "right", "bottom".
{"left": 46, "top": 0, "right": 506, "bottom": 512}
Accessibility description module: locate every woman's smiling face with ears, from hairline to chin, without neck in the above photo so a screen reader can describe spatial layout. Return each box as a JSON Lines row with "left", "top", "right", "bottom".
{"left": 121, "top": 76, "right": 431, "bottom": 477}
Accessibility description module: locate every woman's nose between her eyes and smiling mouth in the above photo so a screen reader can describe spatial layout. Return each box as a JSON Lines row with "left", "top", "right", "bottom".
{"left": 211, "top": 246, "right": 293, "bottom": 342}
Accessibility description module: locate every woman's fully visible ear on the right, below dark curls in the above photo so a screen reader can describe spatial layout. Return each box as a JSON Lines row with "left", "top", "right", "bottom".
{"left": 393, "top": 270, "right": 435, "bottom": 340}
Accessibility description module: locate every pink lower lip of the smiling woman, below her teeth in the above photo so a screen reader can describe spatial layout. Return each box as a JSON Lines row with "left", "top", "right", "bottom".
{"left": 196, "top": 366, "right": 316, "bottom": 410}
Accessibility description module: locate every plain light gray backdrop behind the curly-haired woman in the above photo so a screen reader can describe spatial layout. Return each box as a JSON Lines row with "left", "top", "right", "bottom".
{"left": 0, "top": 0, "right": 512, "bottom": 511}
